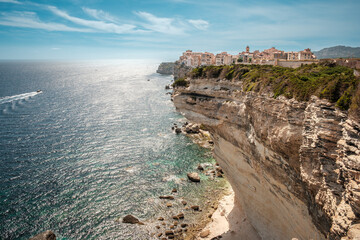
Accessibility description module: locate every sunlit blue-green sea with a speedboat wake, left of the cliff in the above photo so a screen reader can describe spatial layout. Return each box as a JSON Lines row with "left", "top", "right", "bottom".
{"left": 0, "top": 60, "right": 223, "bottom": 239}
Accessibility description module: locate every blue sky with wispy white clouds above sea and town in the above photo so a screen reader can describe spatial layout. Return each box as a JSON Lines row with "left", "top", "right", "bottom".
{"left": 0, "top": 0, "right": 360, "bottom": 61}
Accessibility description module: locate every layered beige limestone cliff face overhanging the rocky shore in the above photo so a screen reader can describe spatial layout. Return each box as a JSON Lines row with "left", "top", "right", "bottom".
{"left": 173, "top": 78, "right": 360, "bottom": 240}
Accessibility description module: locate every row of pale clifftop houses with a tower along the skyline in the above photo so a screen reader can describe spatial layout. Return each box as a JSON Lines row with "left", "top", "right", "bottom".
{"left": 179, "top": 46, "right": 316, "bottom": 67}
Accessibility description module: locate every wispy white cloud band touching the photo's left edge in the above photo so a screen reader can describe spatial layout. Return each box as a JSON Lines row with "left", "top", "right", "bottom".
{"left": 0, "top": 12, "right": 92, "bottom": 32}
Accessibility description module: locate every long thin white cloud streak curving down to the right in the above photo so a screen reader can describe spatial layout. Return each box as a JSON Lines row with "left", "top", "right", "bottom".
{"left": 48, "top": 6, "right": 136, "bottom": 34}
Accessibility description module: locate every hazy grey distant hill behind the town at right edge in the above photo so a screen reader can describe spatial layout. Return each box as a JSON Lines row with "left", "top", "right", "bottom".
{"left": 314, "top": 46, "right": 360, "bottom": 59}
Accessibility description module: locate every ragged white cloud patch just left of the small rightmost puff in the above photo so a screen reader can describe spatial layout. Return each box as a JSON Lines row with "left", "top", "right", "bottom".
{"left": 135, "top": 12, "right": 185, "bottom": 34}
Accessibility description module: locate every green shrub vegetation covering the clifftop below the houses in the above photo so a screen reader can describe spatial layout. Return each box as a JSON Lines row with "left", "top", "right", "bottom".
{"left": 189, "top": 62, "right": 360, "bottom": 112}
